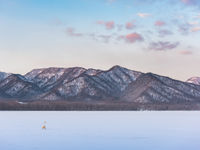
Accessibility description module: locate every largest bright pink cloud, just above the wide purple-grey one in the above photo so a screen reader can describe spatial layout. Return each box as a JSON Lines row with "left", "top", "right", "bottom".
{"left": 117, "top": 32, "right": 144, "bottom": 43}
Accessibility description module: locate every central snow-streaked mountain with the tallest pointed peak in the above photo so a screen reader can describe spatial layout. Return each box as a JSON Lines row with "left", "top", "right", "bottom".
{"left": 42, "top": 66, "right": 141, "bottom": 100}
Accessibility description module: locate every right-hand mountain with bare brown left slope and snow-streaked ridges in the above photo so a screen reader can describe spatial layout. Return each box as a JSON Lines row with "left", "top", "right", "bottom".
{"left": 122, "top": 73, "right": 200, "bottom": 103}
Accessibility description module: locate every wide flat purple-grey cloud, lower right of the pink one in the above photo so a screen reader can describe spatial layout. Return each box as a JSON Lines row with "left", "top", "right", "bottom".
{"left": 149, "top": 41, "right": 180, "bottom": 51}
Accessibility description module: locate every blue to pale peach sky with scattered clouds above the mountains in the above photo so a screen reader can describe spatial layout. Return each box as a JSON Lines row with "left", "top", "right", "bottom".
{"left": 0, "top": 0, "right": 200, "bottom": 81}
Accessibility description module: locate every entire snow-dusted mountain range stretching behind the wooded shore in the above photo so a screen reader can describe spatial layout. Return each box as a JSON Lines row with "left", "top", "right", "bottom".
{"left": 0, "top": 66, "right": 200, "bottom": 103}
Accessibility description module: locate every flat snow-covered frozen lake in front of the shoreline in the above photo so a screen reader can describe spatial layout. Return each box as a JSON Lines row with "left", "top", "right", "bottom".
{"left": 0, "top": 111, "right": 200, "bottom": 150}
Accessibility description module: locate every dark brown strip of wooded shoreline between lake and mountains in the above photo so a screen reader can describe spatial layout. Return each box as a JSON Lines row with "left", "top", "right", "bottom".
{"left": 0, "top": 100, "right": 200, "bottom": 111}
